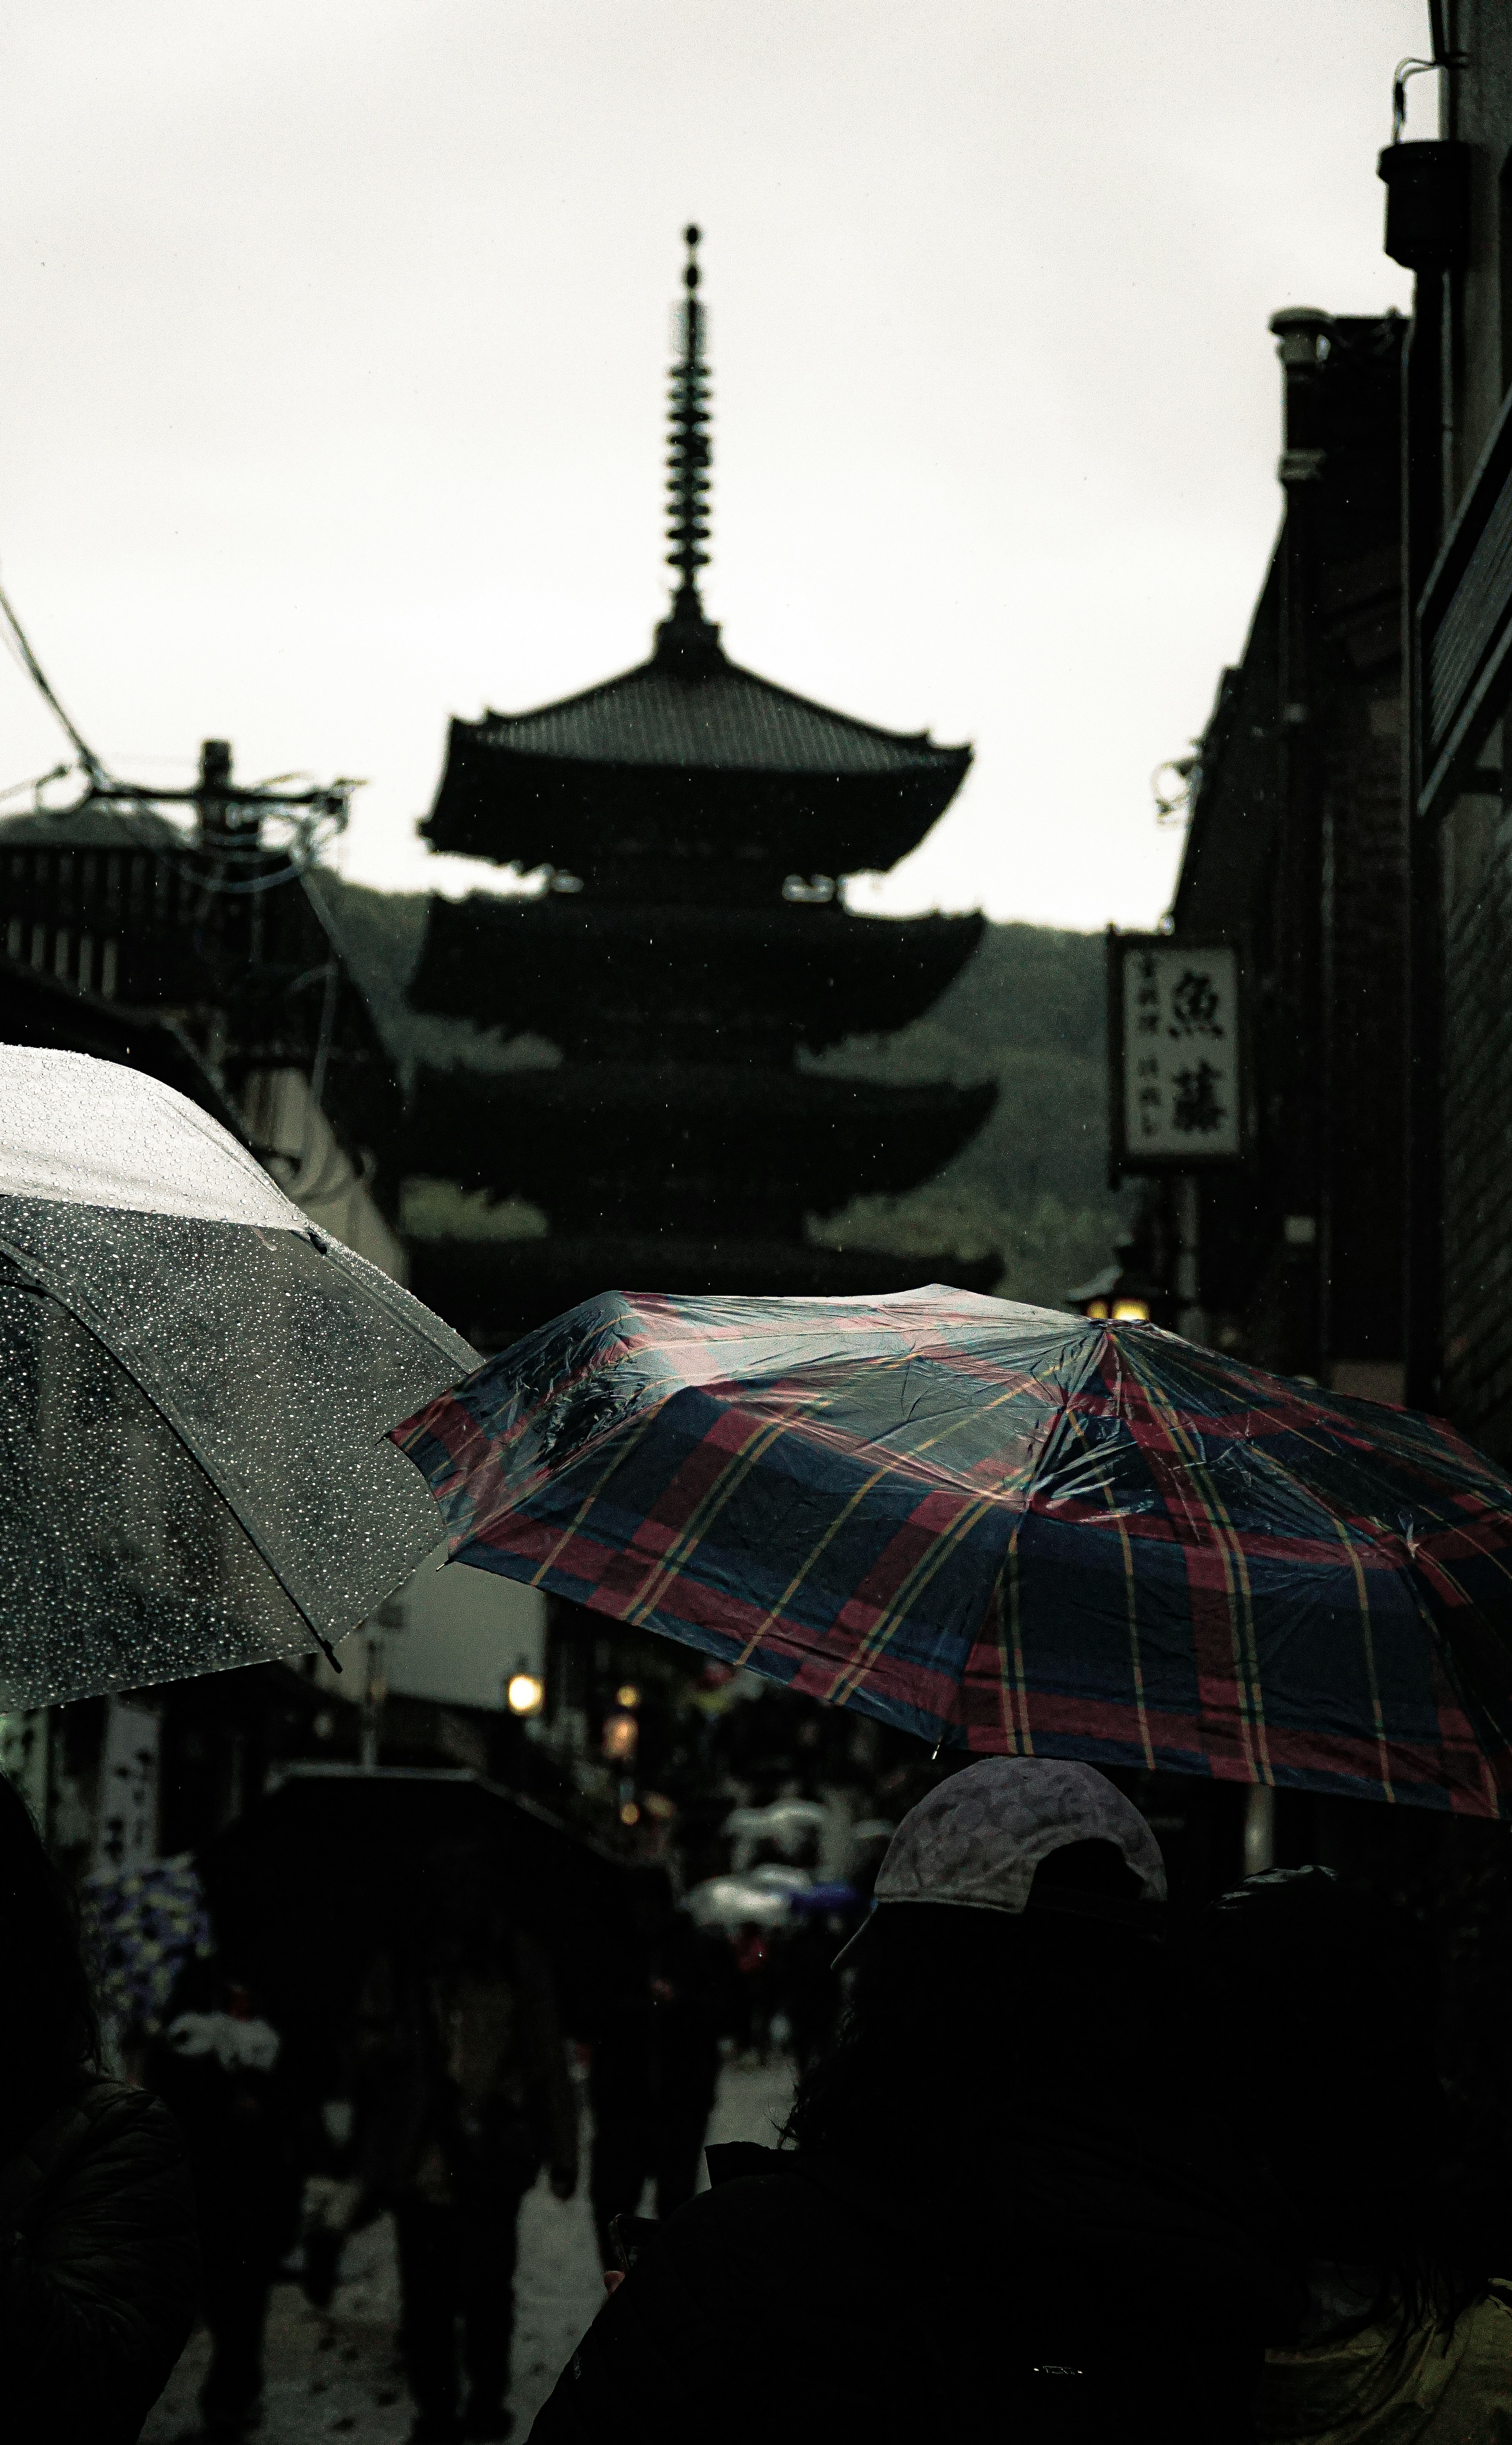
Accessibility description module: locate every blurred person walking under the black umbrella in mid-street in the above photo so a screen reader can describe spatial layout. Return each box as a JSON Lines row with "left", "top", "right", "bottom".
{"left": 354, "top": 1873, "right": 576, "bottom": 2445}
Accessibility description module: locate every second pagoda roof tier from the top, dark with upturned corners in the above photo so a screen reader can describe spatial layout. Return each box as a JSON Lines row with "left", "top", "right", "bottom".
{"left": 408, "top": 892, "right": 984, "bottom": 1051}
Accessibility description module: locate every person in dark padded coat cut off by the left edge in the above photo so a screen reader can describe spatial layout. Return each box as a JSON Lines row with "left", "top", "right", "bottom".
{"left": 0, "top": 1777, "right": 198, "bottom": 2445}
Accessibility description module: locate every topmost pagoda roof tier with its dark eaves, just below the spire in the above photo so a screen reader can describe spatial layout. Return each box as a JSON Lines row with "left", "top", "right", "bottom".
{"left": 420, "top": 623, "right": 972, "bottom": 875}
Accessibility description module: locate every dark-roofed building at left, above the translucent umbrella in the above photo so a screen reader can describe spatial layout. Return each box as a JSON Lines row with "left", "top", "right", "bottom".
{"left": 0, "top": 741, "right": 403, "bottom": 1276}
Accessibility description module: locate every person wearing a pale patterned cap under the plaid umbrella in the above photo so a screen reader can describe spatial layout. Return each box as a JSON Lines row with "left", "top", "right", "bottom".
{"left": 532, "top": 1758, "right": 1302, "bottom": 2445}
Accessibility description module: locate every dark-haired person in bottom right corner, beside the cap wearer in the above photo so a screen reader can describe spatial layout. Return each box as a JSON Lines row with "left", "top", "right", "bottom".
{"left": 1185, "top": 1868, "right": 1512, "bottom": 2445}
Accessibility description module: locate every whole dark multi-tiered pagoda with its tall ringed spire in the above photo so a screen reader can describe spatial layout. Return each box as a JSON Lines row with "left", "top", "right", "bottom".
{"left": 403, "top": 230, "right": 999, "bottom": 1347}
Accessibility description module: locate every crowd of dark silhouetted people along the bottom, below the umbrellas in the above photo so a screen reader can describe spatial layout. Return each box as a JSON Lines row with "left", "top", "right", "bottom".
{"left": 0, "top": 1758, "right": 1512, "bottom": 2445}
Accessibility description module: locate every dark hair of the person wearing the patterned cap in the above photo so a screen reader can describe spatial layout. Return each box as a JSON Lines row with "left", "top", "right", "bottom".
{"left": 782, "top": 1841, "right": 1163, "bottom": 2161}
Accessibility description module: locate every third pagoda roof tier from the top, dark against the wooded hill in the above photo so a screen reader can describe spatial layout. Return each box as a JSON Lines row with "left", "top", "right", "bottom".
{"left": 400, "top": 1061, "right": 997, "bottom": 1237}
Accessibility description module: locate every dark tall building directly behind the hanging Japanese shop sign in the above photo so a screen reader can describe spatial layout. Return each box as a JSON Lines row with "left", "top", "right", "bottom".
{"left": 1119, "top": 308, "right": 1407, "bottom": 1399}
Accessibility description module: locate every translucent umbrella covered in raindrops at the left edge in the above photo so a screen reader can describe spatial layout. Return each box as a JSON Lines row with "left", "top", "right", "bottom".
{"left": 0, "top": 1044, "right": 476, "bottom": 1707}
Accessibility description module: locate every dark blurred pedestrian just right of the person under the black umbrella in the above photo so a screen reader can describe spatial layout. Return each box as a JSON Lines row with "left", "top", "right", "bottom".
{"left": 589, "top": 1868, "right": 740, "bottom": 2267}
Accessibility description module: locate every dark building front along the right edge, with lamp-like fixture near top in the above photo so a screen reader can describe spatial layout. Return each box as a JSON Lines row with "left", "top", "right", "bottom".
{"left": 1382, "top": 0, "right": 1512, "bottom": 1462}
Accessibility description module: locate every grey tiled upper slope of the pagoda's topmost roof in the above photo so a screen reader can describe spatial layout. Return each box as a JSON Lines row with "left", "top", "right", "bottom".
{"left": 471, "top": 655, "right": 967, "bottom": 775}
